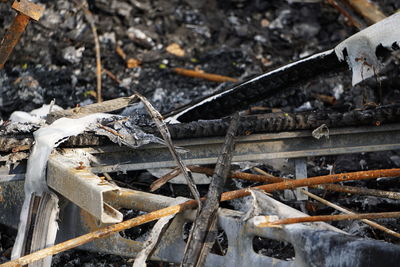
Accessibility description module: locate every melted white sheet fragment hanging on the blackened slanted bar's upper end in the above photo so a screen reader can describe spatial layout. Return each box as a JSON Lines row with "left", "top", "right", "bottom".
{"left": 335, "top": 13, "right": 400, "bottom": 86}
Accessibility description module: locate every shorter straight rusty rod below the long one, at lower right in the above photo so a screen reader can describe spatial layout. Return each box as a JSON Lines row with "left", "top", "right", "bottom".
{"left": 256, "top": 211, "right": 400, "bottom": 227}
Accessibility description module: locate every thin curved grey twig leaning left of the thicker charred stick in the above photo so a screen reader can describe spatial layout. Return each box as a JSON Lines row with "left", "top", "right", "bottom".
{"left": 136, "top": 93, "right": 201, "bottom": 210}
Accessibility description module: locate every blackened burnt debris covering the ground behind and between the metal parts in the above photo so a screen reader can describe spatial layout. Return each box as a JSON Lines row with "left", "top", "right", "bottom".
{"left": 0, "top": 0, "right": 400, "bottom": 266}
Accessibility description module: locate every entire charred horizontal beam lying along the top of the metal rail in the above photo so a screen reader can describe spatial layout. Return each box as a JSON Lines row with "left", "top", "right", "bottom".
{"left": 0, "top": 104, "right": 400, "bottom": 152}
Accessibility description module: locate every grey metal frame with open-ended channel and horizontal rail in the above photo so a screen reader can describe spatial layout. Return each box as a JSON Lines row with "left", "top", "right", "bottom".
{"left": 0, "top": 124, "right": 400, "bottom": 266}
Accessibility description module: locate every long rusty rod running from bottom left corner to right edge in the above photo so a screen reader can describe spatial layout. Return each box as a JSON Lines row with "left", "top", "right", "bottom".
{"left": 0, "top": 169, "right": 400, "bottom": 267}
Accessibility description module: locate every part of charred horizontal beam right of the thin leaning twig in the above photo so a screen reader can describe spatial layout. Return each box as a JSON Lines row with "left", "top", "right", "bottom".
{"left": 168, "top": 104, "right": 400, "bottom": 139}
